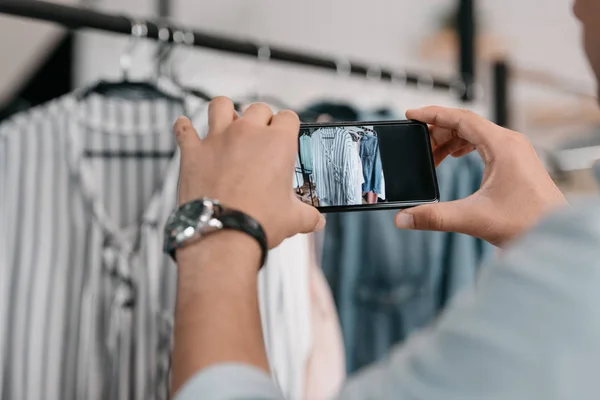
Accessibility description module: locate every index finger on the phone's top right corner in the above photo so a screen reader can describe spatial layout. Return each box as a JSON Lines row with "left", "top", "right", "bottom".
{"left": 406, "top": 106, "right": 497, "bottom": 146}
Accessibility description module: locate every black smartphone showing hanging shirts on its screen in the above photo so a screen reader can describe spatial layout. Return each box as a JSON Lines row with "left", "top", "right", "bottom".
{"left": 294, "top": 120, "right": 439, "bottom": 212}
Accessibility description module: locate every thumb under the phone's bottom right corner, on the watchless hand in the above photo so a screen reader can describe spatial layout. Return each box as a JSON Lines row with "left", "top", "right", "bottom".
{"left": 395, "top": 201, "right": 468, "bottom": 232}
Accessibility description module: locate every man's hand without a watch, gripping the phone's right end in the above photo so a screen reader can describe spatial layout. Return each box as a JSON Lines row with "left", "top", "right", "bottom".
{"left": 396, "top": 107, "right": 567, "bottom": 247}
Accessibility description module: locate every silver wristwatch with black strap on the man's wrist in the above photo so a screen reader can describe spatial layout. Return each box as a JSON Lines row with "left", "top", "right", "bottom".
{"left": 164, "top": 198, "right": 268, "bottom": 268}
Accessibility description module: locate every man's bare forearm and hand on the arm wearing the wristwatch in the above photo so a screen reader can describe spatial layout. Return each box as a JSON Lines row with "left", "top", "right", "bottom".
{"left": 172, "top": 97, "right": 325, "bottom": 399}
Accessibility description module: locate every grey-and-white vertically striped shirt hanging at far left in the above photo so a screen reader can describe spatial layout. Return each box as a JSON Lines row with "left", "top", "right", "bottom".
{"left": 0, "top": 95, "right": 310, "bottom": 400}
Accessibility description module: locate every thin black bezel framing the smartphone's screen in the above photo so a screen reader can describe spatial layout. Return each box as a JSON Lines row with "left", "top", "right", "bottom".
{"left": 298, "top": 119, "right": 440, "bottom": 214}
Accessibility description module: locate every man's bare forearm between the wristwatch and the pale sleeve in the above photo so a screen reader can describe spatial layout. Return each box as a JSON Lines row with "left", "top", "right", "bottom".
{"left": 172, "top": 231, "right": 269, "bottom": 393}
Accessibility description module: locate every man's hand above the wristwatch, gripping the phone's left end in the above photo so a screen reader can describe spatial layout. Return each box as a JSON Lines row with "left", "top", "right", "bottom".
{"left": 175, "top": 97, "right": 325, "bottom": 248}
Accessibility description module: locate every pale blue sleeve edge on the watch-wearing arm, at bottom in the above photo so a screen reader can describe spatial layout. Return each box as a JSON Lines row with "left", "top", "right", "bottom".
{"left": 174, "top": 363, "right": 284, "bottom": 400}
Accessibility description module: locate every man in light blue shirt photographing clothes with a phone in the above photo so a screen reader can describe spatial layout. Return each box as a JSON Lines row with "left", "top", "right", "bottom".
{"left": 166, "top": 0, "right": 600, "bottom": 400}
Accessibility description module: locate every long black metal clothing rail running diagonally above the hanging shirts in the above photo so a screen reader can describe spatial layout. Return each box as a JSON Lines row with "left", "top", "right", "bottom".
{"left": 0, "top": 0, "right": 454, "bottom": 91}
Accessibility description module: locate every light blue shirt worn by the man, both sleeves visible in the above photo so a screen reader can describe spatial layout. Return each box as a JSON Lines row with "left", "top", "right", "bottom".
{"left": 177, "top": 204, "right": 600, "bottom": 400}
